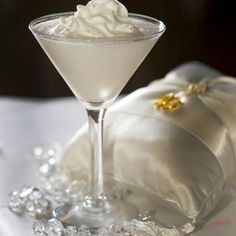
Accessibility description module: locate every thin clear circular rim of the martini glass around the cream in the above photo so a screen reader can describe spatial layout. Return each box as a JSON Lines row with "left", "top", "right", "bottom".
{"left": 28, "top": 11, "right": 166, "bottom": 43}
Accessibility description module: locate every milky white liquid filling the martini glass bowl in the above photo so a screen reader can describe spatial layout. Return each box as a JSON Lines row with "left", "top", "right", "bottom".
{"left": 35, "top": 21, "right": 157, "bottom": 103}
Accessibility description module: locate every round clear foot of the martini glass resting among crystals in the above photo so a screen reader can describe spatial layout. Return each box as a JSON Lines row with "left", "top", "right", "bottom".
{"left": 53, "top": 201, "right": 139, "bottom": 231}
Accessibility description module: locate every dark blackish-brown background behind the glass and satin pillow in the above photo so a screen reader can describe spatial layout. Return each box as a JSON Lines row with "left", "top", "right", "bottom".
{"left": 0, "top": 0, "right": 236, "bottom": 97}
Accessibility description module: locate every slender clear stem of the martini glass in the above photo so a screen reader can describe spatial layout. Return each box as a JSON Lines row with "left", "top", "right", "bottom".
{"left": 84, "top": 109, "right": 108, "bottom": 212}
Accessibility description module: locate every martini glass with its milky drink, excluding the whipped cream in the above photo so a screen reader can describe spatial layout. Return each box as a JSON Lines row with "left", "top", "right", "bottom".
{"left": 29, "top": 12, "right": 165, "bottom": 229}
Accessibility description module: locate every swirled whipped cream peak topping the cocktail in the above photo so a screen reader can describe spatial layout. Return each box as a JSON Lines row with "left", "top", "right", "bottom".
{"left": 50, "top": 0, "right": 140, "bottom": 38}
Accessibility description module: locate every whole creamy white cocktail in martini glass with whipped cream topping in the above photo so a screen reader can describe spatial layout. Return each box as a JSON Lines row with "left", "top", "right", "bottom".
{"left": 30, "top": 0, "right": 165, "bottom": 228}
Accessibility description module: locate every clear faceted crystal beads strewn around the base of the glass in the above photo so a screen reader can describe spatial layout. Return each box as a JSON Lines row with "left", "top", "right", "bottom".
{"left": 9, "top": 147, "right": 195, "bottom": 236}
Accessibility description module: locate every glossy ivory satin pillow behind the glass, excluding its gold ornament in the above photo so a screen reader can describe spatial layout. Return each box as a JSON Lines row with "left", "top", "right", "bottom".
{"left": 61, "top": 63, "right": 236, "bottom": 221}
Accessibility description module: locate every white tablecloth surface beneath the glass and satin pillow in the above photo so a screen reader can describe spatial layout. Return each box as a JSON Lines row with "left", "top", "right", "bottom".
{"left": 0, "top": 97, "right": 236, "bottom": 236}
